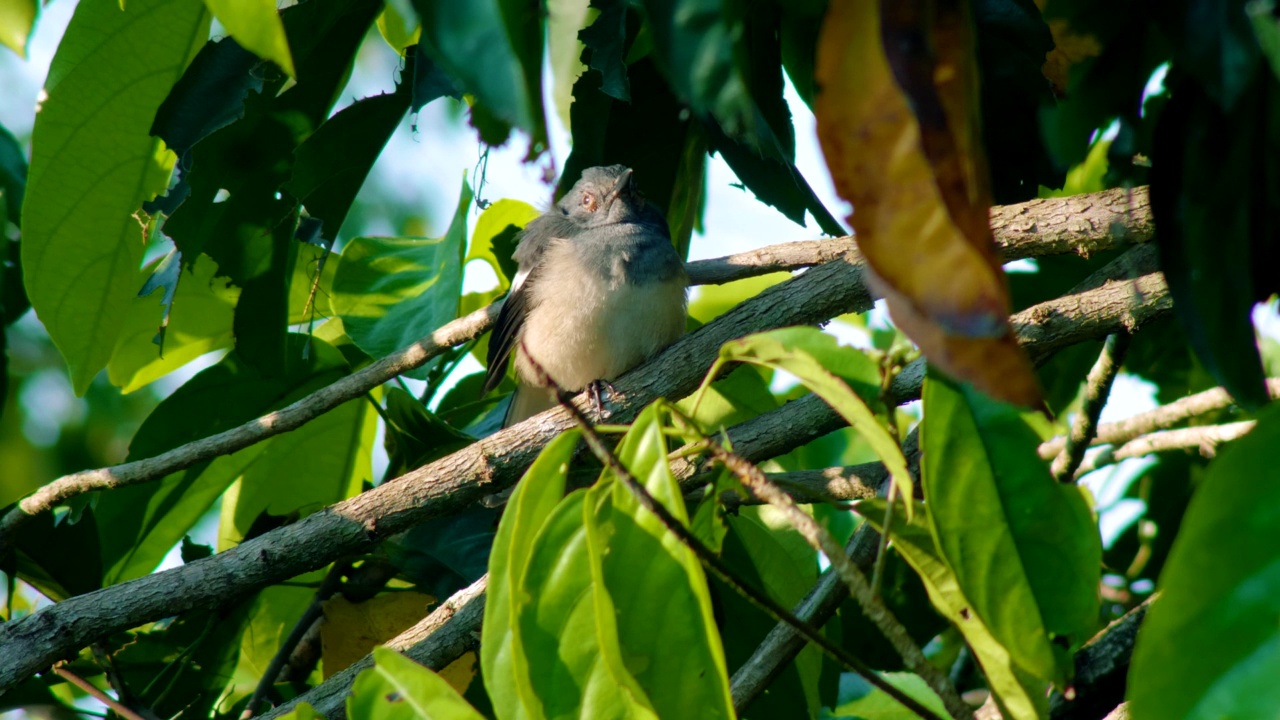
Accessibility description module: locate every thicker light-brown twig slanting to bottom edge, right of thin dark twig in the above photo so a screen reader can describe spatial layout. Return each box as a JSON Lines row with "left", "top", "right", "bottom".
{"left": 708, "top": 443, "right": 973, "bottom": 717}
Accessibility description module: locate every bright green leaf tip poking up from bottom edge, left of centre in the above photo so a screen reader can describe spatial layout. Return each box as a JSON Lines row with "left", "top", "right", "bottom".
{"left": 347, "top": 647, "right": 484, "bottom": 720}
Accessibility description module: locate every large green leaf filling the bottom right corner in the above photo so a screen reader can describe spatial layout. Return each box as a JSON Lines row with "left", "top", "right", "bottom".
{"left": 1128, "top": 407, "right": 1280, "bottom": 720}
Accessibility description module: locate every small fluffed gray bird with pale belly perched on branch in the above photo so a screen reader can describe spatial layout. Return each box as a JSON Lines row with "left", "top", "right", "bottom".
{"left": 484, "top": 165, "right": 689, "bottom": 427}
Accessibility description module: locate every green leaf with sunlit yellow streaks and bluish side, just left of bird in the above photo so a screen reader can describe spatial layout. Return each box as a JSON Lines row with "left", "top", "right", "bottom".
{"left": 333, "top": 179, "right": 472, "bottom": 379}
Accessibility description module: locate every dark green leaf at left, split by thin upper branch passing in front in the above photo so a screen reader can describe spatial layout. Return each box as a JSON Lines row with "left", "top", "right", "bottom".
{"left": 96, "top": 336, "right": 350, "bottom": 583}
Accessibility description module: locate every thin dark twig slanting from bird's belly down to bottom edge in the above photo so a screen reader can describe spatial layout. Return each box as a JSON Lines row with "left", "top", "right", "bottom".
{"left": 526, "top": 352, "right": 941, "bottom": 720}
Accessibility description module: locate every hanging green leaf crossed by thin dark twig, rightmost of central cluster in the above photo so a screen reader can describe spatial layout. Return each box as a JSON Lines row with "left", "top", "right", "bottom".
{"left": 586, "top": 404, "right": 733, "bottom": 717}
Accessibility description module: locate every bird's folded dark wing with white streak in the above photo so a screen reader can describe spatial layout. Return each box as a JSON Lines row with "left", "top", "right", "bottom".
{"left": 481, "top": 213, "right": 570, "bottom": 393}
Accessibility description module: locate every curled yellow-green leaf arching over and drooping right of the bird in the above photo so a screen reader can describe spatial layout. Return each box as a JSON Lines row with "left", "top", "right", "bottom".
{"left": 694, "top": 327, "right": 913, "bottom": 512}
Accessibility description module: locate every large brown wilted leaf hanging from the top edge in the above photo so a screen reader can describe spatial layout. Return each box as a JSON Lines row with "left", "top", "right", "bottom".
{"left": 815, "top": 3, "right": 1039, "bottom": 406}
